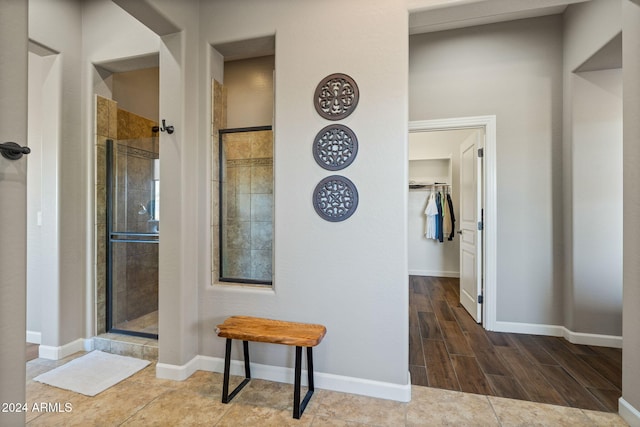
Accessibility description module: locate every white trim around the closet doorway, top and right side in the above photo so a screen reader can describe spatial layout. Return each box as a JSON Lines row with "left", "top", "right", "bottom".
{"left": 409, "top": 116, "right": 498, "bottom": 331}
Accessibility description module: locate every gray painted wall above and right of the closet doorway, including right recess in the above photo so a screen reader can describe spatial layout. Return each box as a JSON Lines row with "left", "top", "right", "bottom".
{"left": 410, "top": 4, "right": 622, "bottom": 336}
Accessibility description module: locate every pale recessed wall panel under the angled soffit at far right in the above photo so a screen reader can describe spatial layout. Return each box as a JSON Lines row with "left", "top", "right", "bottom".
{"left": 572, "top": 69, "right": 623, "bottom": 336}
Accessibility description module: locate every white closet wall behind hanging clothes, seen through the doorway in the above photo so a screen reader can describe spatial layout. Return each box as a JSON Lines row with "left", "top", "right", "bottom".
{"left": 407, "top": 129, "right": 477, "bottom": 277}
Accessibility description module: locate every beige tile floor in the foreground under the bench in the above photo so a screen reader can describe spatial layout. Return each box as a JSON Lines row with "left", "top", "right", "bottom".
{"left": 27, "top": 353, "right": 626, "bottom": 427}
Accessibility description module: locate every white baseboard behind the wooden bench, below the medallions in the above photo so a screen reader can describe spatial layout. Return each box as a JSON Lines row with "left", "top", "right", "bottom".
{"left": 156, "top": 356, "right": 411, "bottom": 402}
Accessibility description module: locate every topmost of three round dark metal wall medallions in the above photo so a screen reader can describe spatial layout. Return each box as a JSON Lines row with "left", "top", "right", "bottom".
{"left": 313, "top": 73, "right": 360, "bottom": 120}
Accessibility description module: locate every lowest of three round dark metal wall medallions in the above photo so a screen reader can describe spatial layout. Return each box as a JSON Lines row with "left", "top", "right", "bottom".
{"left": 313, "top": 175, "right": 358, "bottom": 222}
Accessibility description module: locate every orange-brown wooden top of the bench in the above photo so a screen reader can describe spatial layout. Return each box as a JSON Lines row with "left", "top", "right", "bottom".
{"left": 216, "top": 316, "right": 327, "bottom": 347}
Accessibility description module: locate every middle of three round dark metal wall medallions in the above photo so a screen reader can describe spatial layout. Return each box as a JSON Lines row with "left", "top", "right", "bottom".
{"left": 313, "top": 125, "right": 358, "bottom": 171}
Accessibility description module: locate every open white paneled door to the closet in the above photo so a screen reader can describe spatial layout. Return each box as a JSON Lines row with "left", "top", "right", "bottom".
{"left": 458, "top": 132, "right": 483, "bottom": 323}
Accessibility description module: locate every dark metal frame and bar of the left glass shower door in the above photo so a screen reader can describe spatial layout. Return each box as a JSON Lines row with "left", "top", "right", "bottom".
{"left": 105, "top": 139, "right": 160, "bottom": 339}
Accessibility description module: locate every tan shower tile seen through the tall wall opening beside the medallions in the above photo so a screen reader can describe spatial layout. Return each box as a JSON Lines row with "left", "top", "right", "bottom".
{"left": 211, "top": 80, "right": 273, "bottom": 283}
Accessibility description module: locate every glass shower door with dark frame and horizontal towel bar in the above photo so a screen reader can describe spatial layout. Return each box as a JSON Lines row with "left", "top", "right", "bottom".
{"left": 106, "top": 138, "right": 160, "bottom": 338}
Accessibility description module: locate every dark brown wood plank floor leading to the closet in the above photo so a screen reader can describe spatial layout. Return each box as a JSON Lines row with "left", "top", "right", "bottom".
{"left": 409, "top": 276, "right": 622, "bottom": 412}
